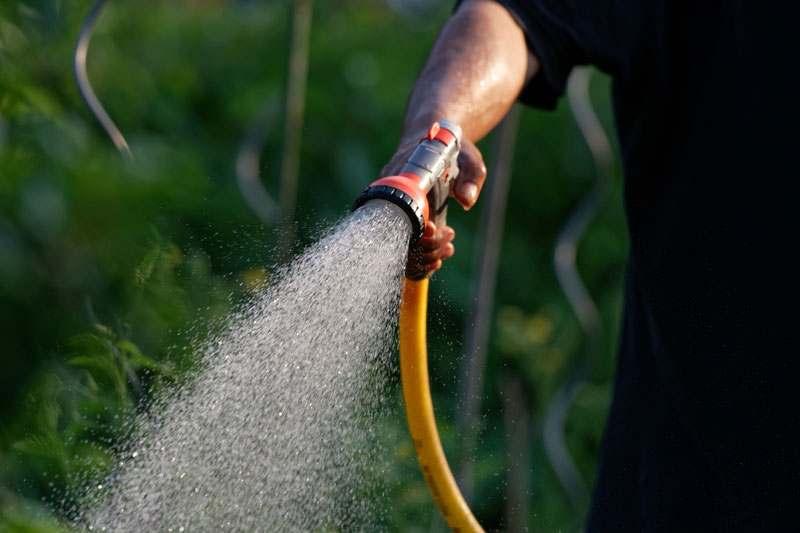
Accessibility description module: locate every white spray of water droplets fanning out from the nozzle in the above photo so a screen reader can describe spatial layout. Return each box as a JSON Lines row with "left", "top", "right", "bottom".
{"left": 75, "top": 202, "right": 410, "bottom": 532}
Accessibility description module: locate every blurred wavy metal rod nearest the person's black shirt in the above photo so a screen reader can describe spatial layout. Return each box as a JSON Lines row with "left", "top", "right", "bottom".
{"left": 543, "top": 68, "right": 613, "bottom": 508}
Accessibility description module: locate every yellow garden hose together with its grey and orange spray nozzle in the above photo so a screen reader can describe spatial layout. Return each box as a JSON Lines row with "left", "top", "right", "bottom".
{"left": 354, "top": 120, "right": 483, "bottom": 532}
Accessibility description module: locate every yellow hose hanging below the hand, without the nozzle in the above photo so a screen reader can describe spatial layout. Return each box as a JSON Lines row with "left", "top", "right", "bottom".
{"left": 400, "top": 279, "right": 483, "bottom": 533}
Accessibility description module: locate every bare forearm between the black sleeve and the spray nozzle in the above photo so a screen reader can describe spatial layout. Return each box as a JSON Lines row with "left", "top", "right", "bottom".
{"left": 403, "top": 0, "right": 538, "bottom": 142}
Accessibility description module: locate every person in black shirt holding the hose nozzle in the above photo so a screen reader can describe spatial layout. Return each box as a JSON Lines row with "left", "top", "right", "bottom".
{"left": 383, "top": 0, "right": 800, "bottom": 532}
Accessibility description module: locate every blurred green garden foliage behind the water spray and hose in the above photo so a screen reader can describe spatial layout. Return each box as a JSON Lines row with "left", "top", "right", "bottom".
{"left": 0, "top": 0, "right": 627, "bottom": 531}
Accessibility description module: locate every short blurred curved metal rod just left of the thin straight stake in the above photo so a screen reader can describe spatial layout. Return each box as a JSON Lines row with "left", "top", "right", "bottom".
{"left": 236, "top": 97, "right": 281, "bottom": 226}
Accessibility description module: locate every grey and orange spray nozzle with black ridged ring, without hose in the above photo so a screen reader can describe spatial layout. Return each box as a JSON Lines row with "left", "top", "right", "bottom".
{"left": 353, "top": 120, "right": 461, "bottom": 242}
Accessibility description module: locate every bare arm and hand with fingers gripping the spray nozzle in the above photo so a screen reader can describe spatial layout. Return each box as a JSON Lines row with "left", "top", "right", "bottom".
{"left": 383, "top": 0, "right": 539, "bottom": 272}
